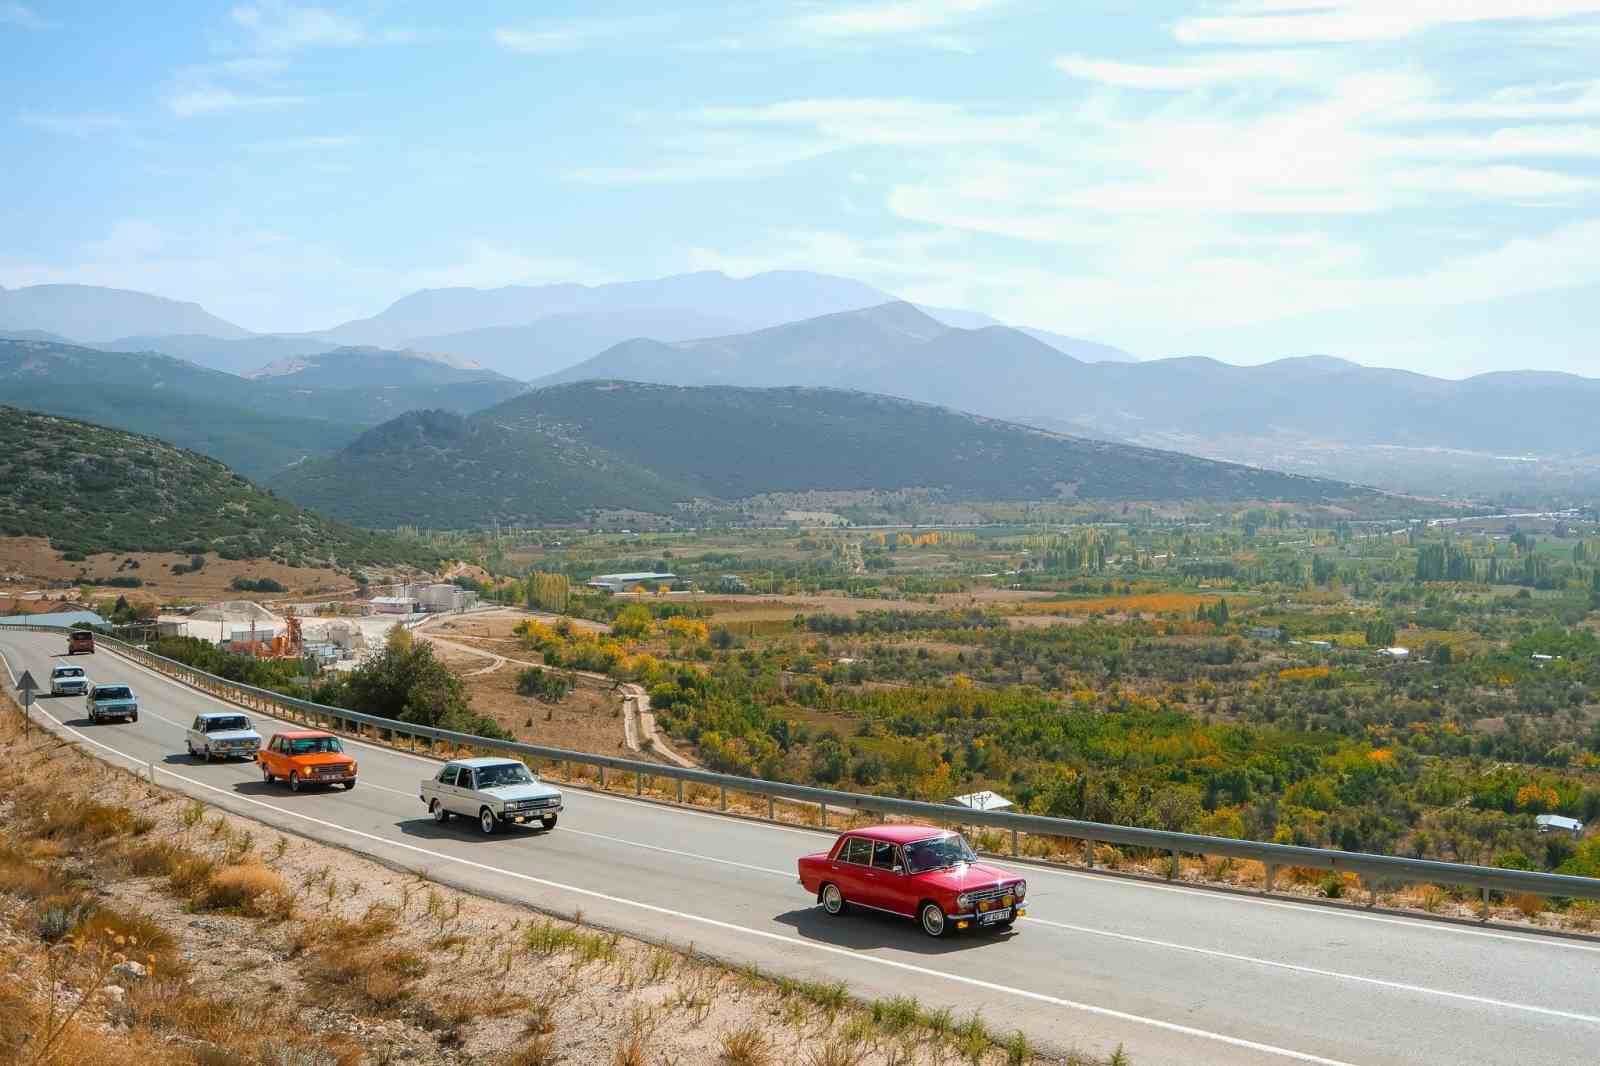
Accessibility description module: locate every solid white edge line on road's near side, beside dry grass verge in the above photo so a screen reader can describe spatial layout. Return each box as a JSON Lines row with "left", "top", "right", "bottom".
{"left": 28, "top": 697, "right": 1354, "bottom": 1066}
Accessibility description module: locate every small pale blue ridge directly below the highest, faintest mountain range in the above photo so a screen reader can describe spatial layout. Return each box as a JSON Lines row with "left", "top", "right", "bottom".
{"left": 406, "top": 307, "right": 742, "bottom": 381}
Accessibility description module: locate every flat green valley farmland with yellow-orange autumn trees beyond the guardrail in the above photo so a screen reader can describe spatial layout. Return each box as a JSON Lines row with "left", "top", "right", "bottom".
{"left": 438, "top": 509, "right": 1600, "bottom": 874}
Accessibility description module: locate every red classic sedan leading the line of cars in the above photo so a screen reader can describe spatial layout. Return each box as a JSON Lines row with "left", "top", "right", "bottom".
{"left": 800, "top": 826, "right": 1027, "bottom": 936}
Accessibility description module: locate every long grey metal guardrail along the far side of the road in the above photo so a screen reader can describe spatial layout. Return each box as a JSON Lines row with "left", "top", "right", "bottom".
{"left": 5, "top": 624, "right": 1600, "bottom": 901}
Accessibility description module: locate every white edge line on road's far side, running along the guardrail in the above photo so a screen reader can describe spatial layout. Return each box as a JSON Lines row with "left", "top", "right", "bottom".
{"left": 15, "top": 633, "right": 1600, "bottom": 952}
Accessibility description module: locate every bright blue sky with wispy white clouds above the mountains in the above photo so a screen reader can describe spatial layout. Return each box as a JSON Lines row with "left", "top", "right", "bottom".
{"left": 0, "top": 0, "right": 1600, "bottom": 376}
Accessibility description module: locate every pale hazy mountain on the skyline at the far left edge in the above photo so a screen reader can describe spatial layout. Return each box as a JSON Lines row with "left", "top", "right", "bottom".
{"left": 0, "top": 285, "right": 250, "bottom": 343}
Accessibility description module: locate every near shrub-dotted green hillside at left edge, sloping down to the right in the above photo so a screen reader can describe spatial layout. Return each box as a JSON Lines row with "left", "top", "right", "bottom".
{"left": 0, "top": 407, "right": 430, "bottom": 567}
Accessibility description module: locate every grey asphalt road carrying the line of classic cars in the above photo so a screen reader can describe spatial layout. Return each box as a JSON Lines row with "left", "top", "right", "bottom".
{"left": 0, "top": 627, "right": 1600, "bottom": 1066}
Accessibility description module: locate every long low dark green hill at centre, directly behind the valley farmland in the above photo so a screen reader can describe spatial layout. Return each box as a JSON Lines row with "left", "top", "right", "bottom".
{"left": 272, "top": 381, "right": 1360, "bottom": 527}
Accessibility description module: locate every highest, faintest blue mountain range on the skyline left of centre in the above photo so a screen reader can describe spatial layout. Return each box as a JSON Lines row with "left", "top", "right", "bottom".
{"left": 326, "top": 271, "right": 890, "bottom": 354}
